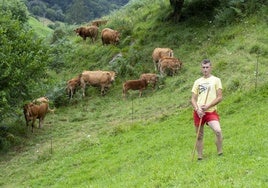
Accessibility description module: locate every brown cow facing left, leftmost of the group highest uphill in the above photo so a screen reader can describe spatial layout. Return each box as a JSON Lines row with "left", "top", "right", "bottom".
{"left": 74, "top": 26, "right": 99, "bottom": 43}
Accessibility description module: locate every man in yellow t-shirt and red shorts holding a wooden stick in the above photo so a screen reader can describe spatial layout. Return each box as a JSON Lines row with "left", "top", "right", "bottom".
{"left": 191, "top": 59, "right": 223, "bottom": 160}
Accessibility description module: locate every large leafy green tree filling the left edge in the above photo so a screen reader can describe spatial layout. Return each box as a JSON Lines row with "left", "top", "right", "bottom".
{"left": 0, "top": 1, "right": 49, "bottom": 122}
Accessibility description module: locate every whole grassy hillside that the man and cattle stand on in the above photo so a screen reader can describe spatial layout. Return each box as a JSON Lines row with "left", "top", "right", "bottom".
{"left": 0, "top": 1, "right": 268, "bottom": 187}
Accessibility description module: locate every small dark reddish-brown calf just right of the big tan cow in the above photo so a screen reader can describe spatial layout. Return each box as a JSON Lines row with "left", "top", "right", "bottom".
{"left": 123, "top": 79, "right": 148, "bottom": 99}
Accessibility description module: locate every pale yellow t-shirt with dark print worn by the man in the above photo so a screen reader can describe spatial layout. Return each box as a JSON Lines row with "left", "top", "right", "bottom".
{"left": 192, "top": 75, "right": 222, "bottom": 112}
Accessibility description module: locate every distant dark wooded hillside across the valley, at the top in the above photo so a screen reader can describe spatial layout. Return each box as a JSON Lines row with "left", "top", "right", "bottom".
{"left": 26, "top": 0, "right": 129, "bottom": 23}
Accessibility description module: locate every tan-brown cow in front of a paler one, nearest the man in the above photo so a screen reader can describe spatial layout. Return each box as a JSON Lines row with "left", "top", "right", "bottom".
{"left": 158, "top": 57, "right": 182, "bottom": 76}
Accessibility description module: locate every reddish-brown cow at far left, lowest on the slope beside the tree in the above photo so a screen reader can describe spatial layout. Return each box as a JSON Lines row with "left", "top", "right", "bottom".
{"left": 23, "top": 102, "right": 48, "bottom": 132}
